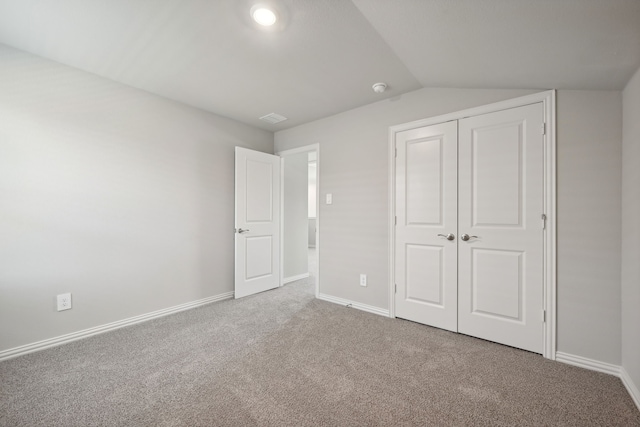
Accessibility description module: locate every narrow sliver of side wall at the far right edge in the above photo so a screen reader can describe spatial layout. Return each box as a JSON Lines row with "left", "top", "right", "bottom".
{"left": 622, "top": 69, "right": 640, "bottom": 398}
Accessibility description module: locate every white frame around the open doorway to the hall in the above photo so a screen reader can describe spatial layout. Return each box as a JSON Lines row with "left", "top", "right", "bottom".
{"left": 275, "top": 144, "right": 320, "bottom": 298}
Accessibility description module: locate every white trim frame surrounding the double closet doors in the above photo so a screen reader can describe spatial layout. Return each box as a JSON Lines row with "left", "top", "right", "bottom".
{"left": 388, "top": 90, "right": 557, "bottom": 360}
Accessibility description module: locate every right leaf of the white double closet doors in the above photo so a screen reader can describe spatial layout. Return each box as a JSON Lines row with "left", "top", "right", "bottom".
{"left": 458, "top": 103, "right": 544, "bottom": 353}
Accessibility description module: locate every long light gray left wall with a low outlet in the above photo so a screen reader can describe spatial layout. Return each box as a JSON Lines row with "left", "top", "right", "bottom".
{"left": 0, "top": 45, "right": 273, "bottom": 351}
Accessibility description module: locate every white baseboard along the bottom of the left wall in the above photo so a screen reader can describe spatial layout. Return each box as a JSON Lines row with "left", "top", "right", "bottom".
{"left": 0, "top": 292, "right": 233, "bottom": 361}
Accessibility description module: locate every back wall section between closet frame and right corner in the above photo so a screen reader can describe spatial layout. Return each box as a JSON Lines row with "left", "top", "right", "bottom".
{"left": 557, "top": 91, "right": 622, "bottom": 365}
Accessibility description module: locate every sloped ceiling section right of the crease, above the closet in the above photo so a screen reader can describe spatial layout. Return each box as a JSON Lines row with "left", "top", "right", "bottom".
{"left": 353, "top": 0, "right": 640, "bottom": 90}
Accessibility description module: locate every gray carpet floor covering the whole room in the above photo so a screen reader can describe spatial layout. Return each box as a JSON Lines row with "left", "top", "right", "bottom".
{"left": 0, "top": 252, "right": 640, "bottom": 426}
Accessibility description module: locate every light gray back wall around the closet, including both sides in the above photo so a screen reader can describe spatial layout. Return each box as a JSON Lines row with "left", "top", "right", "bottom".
{"left": 275, "top": 89, "right": 621, "bottom": 364}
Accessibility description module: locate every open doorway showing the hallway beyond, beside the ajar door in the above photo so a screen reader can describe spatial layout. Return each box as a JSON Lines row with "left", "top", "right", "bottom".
{"left": 278, "top": 144, "right": 320, "bottom": 297}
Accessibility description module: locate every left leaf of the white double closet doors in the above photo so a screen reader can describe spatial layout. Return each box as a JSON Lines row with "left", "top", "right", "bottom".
{"left": 395, "top": 121, "right": 457, "bottom": 331}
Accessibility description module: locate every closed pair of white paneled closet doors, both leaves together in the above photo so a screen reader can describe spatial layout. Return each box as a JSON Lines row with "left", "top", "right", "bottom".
{"left": 395, "top": 103, "right": 544, "bottom": 353}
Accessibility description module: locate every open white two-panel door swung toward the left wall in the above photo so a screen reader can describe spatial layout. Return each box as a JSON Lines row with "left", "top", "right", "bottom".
{"left": 235, "top": 147, "right": 280, "bottom": 298}
